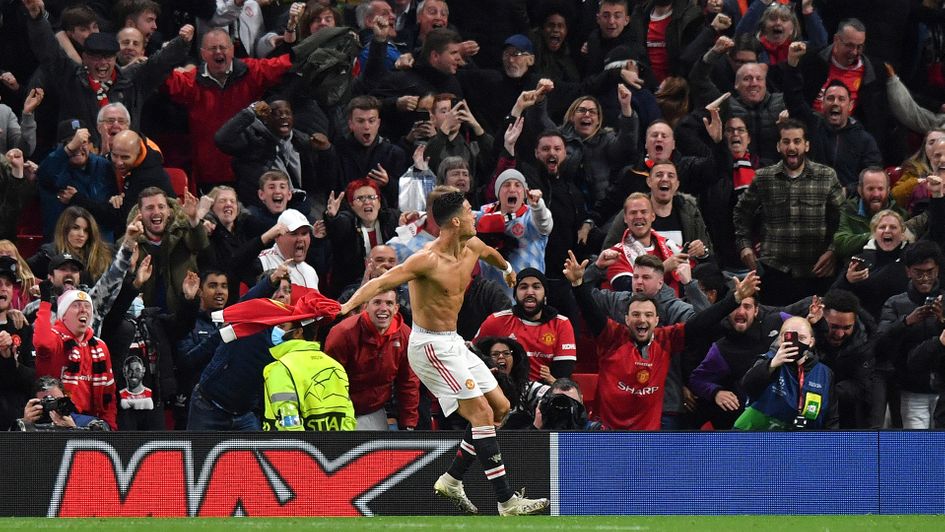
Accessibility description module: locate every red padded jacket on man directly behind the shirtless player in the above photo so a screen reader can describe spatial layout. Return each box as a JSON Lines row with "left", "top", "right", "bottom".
{"left": 324, "top": 311, "right": 420, "bottom": 428}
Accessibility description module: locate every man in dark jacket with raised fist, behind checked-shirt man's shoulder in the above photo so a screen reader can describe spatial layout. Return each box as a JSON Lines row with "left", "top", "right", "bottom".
{"left": 780, "top": 42, "right": 883, "bottom": 192}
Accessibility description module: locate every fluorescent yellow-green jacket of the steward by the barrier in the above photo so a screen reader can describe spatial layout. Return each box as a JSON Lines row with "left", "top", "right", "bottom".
{"left": 263, "top": 340, "right": 357, "bottom": 431}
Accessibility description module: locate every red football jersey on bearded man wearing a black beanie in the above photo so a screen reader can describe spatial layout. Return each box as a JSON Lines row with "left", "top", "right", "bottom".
{"left": 476, "top": 310, "right": 577, "bottom": 381}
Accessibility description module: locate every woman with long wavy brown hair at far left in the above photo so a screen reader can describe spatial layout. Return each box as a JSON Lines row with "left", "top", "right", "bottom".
{"left": 29, "top": 206, "right": 112, "bottom": 286}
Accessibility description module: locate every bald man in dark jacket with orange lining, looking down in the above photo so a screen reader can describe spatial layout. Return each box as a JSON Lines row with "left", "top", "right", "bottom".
{"left": 108, "top": 129, "right": 177, "bottom": 228}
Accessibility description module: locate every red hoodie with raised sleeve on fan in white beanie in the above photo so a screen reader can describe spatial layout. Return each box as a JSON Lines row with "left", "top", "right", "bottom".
{"left": 33, "top": 301, "right": 118, "bottom": 430}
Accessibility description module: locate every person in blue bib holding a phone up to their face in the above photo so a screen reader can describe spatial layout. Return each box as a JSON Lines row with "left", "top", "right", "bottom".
{"left": 734, "top": 316, "right": 840, "bottom": 430}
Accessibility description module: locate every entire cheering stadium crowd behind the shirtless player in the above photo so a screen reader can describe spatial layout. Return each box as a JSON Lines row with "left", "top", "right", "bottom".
{"left": 0, "top": 0, "right": 945, "bottom": 430}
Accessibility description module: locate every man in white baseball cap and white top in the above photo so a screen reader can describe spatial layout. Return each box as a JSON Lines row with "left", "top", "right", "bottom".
{"left": 255, "top": 209, "right": 318, "bottom": 290}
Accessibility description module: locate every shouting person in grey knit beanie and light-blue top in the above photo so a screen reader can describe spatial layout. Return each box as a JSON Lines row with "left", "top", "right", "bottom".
{"left": 476, "top": 168, "right": 553, "bottom": 296}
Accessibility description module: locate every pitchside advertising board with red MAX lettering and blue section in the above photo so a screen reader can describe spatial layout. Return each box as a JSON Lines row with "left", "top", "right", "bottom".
{"left": 0, "top": 431, "right": 945, "bottom": 517}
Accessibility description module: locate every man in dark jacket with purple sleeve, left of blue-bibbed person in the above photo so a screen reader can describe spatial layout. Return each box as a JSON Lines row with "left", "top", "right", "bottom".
{"left": 689, "top": 297, "right": 784, "bottom": 430}
